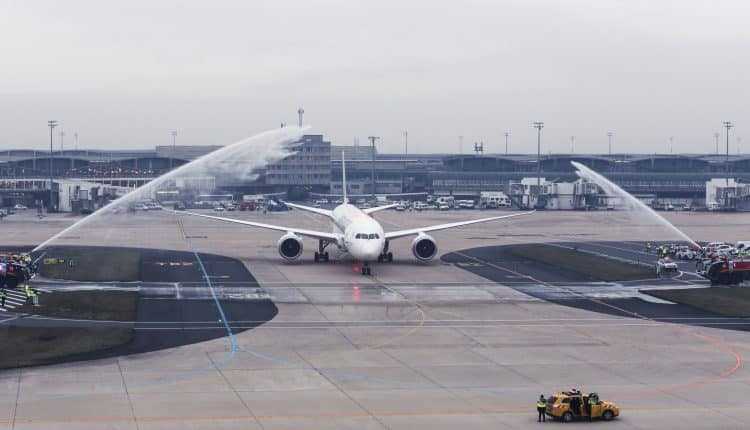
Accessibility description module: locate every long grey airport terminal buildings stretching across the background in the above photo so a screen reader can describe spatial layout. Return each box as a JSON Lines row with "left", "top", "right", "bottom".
{"left": 0, "top": 135, "right": 750, "bottom": 207}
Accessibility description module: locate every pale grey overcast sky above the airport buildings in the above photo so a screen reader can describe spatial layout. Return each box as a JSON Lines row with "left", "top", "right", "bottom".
{"left": 0, "top": 0, "right": 750, "bottom": 153}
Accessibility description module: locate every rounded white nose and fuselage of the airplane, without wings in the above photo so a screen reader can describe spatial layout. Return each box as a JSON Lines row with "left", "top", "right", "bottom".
{"left": 333, "top": 203, "right": 385, "bottom": 262}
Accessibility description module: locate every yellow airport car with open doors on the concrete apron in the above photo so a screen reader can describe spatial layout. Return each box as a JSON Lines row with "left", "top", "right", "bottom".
{"left": 546, "top": 390, "right": 620, "bottom": 423}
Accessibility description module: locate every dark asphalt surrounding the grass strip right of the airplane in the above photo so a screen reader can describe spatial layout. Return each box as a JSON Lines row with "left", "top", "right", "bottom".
{"left": 442, "top": 242, "right": 750, "bottom": 331}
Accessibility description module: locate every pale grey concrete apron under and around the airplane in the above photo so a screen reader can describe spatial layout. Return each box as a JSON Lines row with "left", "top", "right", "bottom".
{"left": 0, "top": 212, "right": 750, "bottom": 430}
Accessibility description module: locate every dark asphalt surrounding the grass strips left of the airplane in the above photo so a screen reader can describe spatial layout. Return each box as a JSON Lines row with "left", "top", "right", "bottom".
{"left": 2, "top": 247, "right": 278, "bottom": 361}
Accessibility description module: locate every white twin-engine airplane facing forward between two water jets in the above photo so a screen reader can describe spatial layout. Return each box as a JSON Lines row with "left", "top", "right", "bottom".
{"left": 175, "top": 154, "right": 534, "bottom": 275}
